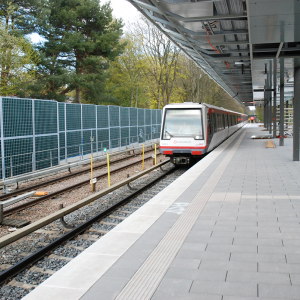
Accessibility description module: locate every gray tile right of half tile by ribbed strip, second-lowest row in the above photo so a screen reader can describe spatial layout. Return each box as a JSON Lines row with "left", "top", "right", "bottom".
{"left": 190, "top": 280, "right": 257, "bottom": 297}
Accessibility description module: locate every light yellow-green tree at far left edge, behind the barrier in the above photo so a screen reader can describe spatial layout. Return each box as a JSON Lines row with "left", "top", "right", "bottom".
{"left": 0, "top": 1, "right": 38, "bottom": 96}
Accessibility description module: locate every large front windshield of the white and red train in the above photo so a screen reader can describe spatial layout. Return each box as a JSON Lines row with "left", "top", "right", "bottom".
{"left": 163, "top": 108, "right": 203, "bottom": 140}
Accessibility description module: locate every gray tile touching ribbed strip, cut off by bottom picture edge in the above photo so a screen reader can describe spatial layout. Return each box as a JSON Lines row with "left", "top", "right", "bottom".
{"left": 151, "top": 291, "right": 222, "bottom": 300}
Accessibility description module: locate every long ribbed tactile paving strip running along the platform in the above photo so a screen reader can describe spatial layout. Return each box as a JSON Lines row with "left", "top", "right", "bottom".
{"left": 115, "top": 130, "right": 247, "bottom": 300}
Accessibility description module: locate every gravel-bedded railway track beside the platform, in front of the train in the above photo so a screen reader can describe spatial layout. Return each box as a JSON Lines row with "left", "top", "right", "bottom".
{"left": 0, "top": 164, "right": 188, "bottom": 299}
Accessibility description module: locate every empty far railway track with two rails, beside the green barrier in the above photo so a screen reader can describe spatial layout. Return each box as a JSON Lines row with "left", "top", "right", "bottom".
{"left": 0, "top": 150, "right": 162, "bottom": 217}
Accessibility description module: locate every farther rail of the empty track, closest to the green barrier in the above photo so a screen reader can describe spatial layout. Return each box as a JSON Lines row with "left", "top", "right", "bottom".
{"left": 0, "top": 149, "right": 153, "bottom": 201}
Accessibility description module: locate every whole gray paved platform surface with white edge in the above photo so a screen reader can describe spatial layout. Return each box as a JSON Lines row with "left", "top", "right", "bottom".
{"left": 24, "top": 124, "right": 300, "bottom": 300}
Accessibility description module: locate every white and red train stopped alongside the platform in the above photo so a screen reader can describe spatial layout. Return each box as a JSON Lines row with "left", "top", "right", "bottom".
{"left": 159, "top": 102, "right": 248, "bottom": 165}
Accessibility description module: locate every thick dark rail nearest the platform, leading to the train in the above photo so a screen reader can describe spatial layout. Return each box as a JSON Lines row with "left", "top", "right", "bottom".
{"left": 0, "top": 168, "right": 175, "bottom": 283}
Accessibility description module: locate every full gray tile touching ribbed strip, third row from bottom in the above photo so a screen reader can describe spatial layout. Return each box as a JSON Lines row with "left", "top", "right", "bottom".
{"left": 164, "top": 268, "right": 226, "bottom": 282}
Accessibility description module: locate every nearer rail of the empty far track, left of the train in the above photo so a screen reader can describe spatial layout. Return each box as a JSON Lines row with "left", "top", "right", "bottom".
{"left": 3, "top": 157, "right": 162, "bottom": 216}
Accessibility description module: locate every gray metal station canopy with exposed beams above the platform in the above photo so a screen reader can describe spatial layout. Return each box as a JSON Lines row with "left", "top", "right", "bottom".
{"left": 128, "top": 0, "right": 300, "bottom": 106}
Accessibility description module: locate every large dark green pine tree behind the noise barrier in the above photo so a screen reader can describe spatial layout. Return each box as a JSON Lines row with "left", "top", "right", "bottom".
{"left": 35, "top": 0, "right": 124, "bottom": 103}
